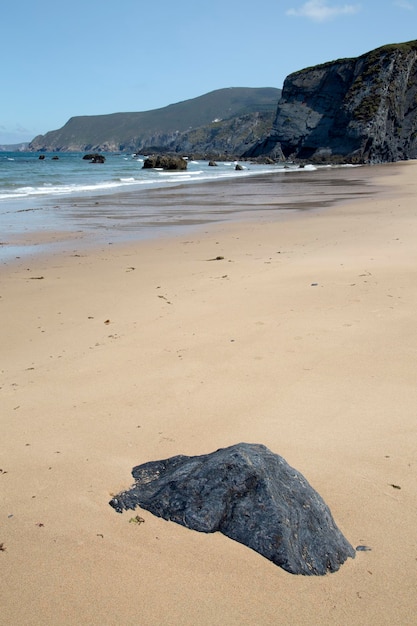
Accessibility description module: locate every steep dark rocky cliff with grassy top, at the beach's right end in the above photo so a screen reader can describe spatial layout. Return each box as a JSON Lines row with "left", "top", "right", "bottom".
{"left": 244, "top": 41, "right": 417, "bottom": 163}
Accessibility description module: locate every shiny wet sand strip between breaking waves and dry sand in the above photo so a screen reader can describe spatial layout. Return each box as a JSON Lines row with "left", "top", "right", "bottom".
{"left": 0, "top": 164, "right": 392, "bottom": 262}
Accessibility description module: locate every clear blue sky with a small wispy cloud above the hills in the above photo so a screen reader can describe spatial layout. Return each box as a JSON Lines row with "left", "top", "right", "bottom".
{"left": 0, "top": 0, "right": 417, "bottom": 144}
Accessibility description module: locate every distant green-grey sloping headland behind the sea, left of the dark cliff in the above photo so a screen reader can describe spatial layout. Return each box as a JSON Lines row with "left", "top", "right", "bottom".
{"left": 29, "top": 87, "right": 281, "bottom": 154}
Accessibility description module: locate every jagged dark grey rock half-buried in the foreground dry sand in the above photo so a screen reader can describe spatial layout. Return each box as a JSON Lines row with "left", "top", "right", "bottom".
{"left": 109, "top": 443, "right": 355, "bottom": 575}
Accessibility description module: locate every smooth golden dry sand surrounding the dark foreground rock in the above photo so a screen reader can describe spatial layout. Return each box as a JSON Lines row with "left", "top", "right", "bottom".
{"left": 0, "top": 162, "right": 417, "bottom": 626}
